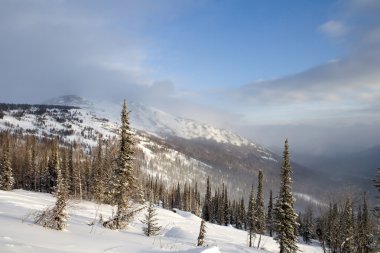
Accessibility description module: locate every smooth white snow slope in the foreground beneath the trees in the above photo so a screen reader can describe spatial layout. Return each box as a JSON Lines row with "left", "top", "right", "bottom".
{"left": 0, "top": 190, "right": 322, "bottom": 253}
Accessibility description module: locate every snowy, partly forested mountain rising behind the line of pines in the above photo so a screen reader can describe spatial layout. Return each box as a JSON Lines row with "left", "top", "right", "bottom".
{"left": 0, "top": 96, "right": 352, "bottom": 208}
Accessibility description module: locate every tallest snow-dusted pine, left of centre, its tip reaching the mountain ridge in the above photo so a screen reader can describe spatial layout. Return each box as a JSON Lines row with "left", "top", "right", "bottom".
{"left": 103, "top": 100, "right": 138, "bottom": 229}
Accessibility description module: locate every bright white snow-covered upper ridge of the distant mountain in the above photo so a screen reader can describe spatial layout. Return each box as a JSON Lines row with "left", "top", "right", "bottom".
{"left": 45, "top": 95, "right": 255, "bottom": 146}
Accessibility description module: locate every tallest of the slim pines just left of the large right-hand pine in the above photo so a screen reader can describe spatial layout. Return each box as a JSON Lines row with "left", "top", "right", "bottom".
{"left": 255, "top": 170, "right": 265, "bottom": 248}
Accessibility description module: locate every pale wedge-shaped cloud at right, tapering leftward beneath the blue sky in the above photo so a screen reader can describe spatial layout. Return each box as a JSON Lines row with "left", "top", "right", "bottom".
{"left": 232, "top": 0, "right": 380, "bottom": 106}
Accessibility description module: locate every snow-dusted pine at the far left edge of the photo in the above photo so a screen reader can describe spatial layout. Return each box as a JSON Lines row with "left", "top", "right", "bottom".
{"left": 0, "top": 140, "right": 15, "bottom": 191}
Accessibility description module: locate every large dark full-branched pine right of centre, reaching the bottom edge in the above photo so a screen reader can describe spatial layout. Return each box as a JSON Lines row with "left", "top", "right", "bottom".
{"left": 275, "top": 139, "right": 298, "bottom": 253}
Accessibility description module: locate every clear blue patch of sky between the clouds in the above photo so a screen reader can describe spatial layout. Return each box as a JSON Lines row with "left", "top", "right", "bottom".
{"left": 147, "top": 1, "right": 342, "bottom": 90}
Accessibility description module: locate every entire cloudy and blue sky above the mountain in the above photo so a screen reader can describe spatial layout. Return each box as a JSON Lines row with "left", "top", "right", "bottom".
{"left": 0, "top": 0, "right": 380, "bottom": 154}
